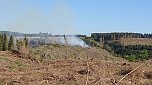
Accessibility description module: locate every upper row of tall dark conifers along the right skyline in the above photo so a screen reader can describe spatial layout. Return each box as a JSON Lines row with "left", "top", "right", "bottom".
{"left": 91, "top": 32, "right": 152, "bottom": 41}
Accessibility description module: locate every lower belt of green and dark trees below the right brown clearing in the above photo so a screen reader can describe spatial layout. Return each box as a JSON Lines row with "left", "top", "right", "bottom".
{"left": 104, "top": 42, "right": 152, "bottom": 61}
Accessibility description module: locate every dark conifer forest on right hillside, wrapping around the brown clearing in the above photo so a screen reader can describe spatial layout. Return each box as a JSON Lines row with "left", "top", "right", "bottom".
{"left": 91, "top": 33, "right": 152, "bottom": 62}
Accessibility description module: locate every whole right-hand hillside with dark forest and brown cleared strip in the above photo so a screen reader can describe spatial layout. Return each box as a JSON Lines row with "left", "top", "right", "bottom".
{"left": 85, "top": 32, "right": 152, "bottom": 62}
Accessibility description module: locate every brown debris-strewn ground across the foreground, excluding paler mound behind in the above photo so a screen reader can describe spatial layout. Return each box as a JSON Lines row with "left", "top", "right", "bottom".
{"left": 0, "top": 46, "right": 152, "bottom": 85}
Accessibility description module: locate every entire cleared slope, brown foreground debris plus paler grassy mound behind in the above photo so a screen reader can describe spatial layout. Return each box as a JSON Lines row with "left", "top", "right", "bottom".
{"left": 0, "top": 45, "right": 152, "bottom": 85}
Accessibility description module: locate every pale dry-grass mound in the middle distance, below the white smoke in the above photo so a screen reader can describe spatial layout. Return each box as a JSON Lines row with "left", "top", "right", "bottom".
{"left": 31, "top": 45, "right": 124, "bottom": 62}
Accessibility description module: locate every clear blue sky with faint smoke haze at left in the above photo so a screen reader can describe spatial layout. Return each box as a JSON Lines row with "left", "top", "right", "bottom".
{"left": 0, "top": 0, "right": 152, "bottom": 35}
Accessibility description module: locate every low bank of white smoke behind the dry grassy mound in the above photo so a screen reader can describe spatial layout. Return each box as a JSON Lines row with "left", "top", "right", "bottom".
{"left": 15, "top": 35, "right": 89, "bottom": 47}
